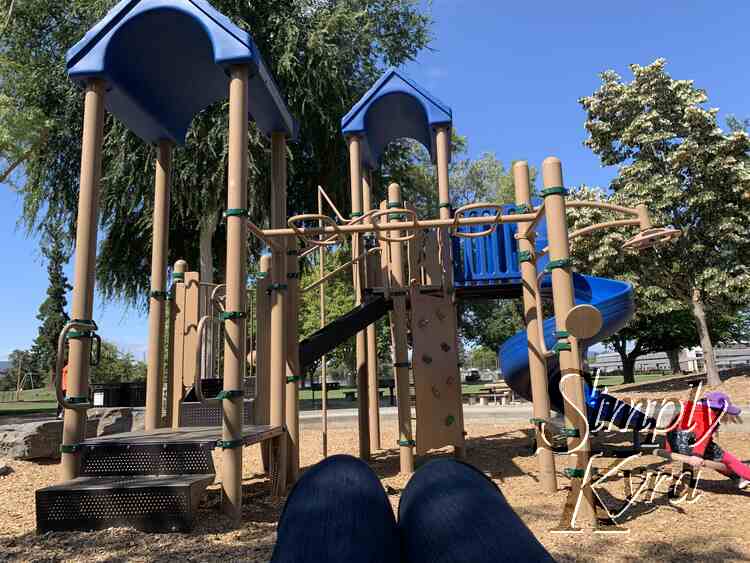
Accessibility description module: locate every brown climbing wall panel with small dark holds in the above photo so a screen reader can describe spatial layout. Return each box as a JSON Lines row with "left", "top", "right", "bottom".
{"left": 411, "top": 286, "right": 464, "bottom": 455}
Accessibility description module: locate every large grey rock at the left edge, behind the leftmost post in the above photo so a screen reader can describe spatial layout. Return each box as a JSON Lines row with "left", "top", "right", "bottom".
{"left": 0, "top": 419, "right": 99, "bottom": 460}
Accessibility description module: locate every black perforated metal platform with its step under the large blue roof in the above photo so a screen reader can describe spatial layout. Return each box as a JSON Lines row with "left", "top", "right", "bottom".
{"left": 36, "top": 426, "right": 283, "bottom": 533}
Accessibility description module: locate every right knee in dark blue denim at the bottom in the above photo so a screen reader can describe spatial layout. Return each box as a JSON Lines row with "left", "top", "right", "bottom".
{"left": 399, "top": 459, "right": 553, "bottom": 563}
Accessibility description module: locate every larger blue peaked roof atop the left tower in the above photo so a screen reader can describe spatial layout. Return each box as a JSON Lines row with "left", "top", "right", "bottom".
{"left": 67, "top": 0, "right": 297, "bottom": 144}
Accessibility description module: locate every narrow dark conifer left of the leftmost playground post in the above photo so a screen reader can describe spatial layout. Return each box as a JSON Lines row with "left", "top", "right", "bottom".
{"left": 32, "top": 225, "right": 71, "bottom": 388}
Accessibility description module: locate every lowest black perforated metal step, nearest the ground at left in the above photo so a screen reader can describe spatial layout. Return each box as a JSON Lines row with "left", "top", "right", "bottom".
{"left": 36, "top": 474, "right": 214, "bottom": 533}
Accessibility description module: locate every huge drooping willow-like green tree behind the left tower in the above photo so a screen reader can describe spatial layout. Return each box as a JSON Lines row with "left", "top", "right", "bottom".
{"left": 0, "top": 0, "right": 430, "bottom": 305}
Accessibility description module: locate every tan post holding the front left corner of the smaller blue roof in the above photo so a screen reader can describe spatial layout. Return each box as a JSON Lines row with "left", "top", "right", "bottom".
{"left": 348, "top": 136, "right": 370, "bottom": 459}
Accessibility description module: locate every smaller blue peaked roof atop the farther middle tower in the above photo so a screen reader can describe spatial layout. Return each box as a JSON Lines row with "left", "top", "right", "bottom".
{"left": 341, "top": 68, "right": 453, "bottom": 168}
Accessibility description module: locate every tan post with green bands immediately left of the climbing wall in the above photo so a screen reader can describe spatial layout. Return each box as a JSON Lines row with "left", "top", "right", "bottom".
{"left": 388, "top": 184, "right": 414, "bottom": 474}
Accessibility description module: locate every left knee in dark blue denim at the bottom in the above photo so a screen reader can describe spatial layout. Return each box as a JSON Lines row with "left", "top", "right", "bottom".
{"left": 272, "top": 455, "right": 400, "bottom": 563}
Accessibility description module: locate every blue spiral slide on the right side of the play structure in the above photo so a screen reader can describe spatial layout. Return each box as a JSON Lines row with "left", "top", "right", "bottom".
{"left": 499, "top": 273, "right": 652, "bottom": 428}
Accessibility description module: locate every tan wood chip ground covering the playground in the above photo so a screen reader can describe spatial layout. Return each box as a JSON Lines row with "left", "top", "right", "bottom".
{"left": 0, "top": 420, "right": 750, "bottom": 562}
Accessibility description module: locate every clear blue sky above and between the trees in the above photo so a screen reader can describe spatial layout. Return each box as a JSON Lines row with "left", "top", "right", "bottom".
{"left": 0, "top": 0, "right": 750, "bottom": 360}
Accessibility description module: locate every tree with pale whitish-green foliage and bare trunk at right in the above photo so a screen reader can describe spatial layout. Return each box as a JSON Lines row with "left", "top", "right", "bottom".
{"left": 580, "top": 59, "right": 750, "bottom": 384}
